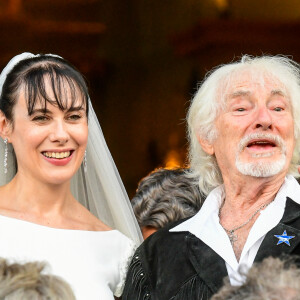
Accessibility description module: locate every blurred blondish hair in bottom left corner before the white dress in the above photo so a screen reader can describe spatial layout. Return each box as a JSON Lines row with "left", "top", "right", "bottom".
{"left": 0, "top": 259, "right": 75, "bottom": 300}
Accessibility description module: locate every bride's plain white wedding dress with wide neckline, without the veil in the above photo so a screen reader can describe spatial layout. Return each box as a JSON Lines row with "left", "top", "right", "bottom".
{"left": 0, "top": 215, "right": 135, "bottom": 300}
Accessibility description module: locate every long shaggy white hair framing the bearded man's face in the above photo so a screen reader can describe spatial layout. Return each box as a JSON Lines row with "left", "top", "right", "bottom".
{"left": 187, "top": 55, "right": 300, "bottom": 195}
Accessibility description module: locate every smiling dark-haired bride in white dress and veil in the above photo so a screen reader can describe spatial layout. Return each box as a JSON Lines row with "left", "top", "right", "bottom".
{"left": 0, "top": 53, "right": 141, "bottom": 300}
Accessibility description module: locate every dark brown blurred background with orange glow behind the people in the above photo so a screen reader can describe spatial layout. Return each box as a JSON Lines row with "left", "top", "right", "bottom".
{"left": 0, "top": 0, "right": 300, "bottom": 196}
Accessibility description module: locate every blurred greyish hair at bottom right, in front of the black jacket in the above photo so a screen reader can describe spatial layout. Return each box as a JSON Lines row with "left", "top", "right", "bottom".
{"left": 211, "top": 257, "right": 300, "bottom": 300}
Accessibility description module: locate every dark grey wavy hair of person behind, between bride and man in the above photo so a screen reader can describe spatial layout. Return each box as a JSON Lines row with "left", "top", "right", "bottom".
{"left": 131, "top": 169, "right": 203, "bottom": 229}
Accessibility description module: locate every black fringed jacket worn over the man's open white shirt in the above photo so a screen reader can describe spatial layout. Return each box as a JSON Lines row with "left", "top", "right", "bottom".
{"left": 122, "top": 198, "right": 300, "bottom": 300}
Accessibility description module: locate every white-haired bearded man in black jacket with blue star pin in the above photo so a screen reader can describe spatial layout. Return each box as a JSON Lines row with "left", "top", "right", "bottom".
{"left": 122, "top": 56, "right": 300, "bottom": 300}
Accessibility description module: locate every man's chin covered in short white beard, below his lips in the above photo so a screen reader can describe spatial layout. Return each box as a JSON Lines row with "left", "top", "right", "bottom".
{"left": 236, "top": 155, "right": 286, "bottom": 177}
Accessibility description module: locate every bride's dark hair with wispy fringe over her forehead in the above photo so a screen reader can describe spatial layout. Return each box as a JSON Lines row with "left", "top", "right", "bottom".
{"left": 0, "top": 55, "right": 89, "bottom": 121}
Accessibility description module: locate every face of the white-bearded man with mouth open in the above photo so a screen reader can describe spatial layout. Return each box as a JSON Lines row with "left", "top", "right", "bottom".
{"left": 212, "top": 75, "right": 295, "bottom": 178}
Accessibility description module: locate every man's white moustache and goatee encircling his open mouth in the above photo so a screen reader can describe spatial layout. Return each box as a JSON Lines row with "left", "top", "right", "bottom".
{"left": 235, "top": 133, "right": 286, "bottom": 177}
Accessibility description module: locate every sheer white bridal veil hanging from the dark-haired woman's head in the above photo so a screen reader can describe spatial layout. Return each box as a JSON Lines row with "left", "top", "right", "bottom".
{"left": 0, "top": 53, "right": 142, "bottom": 244}
